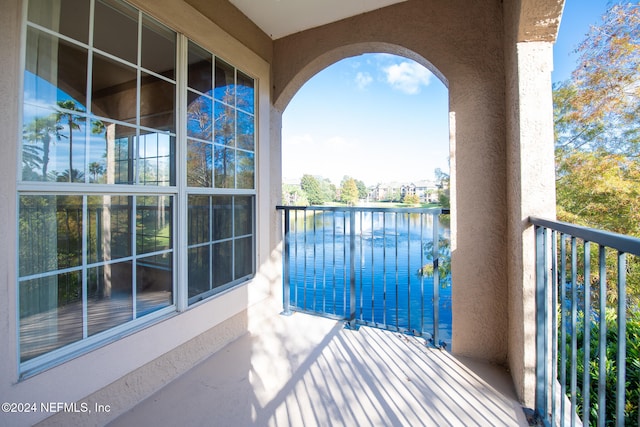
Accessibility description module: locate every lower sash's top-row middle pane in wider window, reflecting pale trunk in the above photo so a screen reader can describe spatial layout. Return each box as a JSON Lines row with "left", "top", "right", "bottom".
{"left": 87, "top": 196, "right": 133, "bottom": 264}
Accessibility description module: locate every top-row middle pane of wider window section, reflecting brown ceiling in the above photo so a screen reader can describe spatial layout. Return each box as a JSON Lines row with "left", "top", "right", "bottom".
{"left": 93, "top": 0, "right": 138, "bottom": 64}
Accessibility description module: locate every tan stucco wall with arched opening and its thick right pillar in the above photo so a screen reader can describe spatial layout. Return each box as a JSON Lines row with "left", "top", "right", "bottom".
{"left": 273, "top": 0, "right": 508, "bottom": 363}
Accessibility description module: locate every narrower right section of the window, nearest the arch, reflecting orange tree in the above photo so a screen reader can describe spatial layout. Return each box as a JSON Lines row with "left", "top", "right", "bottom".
{"left": 186, "top": 42, "right": 255, "bottom": 303}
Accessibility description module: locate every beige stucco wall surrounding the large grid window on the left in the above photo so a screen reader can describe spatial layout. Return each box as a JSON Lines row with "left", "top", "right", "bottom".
{"left": 0, "top": 0, "right": 282, "bottom": 426}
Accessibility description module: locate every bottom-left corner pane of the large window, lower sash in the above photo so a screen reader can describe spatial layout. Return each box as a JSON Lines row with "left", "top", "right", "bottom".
{"left": 19, "top": 271, "right": 83, "bottom": 362}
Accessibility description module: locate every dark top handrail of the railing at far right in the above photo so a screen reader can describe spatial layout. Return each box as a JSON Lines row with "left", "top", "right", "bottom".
{"left": 529, "top": 217, "right": 640, "bottom": 256}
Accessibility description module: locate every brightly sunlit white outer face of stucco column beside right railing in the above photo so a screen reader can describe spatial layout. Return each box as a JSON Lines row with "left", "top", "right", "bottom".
{"left": 506, "top": 41, "right": 556, "bottom": 407}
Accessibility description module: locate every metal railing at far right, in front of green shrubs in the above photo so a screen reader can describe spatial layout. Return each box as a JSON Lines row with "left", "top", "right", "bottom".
{"left": 530, "top": 218, "right": 640, "bottom": 426}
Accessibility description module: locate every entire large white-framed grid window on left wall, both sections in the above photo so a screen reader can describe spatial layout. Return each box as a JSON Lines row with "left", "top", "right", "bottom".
{"left": 17, "top": 0, "right": 255, "bottom": 369}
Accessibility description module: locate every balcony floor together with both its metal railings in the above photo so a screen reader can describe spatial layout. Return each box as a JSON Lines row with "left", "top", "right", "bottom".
{"left": 104, "top": 207, "right": 640, "bottom": 426}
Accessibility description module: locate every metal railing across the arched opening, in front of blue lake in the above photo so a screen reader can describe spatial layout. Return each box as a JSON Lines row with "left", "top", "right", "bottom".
{"left": 276, "top": 206, "right": 451, "bottom": 346}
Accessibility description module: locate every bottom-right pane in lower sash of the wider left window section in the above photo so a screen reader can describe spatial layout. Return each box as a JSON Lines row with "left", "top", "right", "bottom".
{"left": 136, "top": 253, "right": 173, "bottom": 317}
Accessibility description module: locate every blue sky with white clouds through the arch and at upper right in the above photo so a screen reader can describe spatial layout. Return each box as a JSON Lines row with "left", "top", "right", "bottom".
{"left": 282, "top": 0, "right": 611, "bottom": 186}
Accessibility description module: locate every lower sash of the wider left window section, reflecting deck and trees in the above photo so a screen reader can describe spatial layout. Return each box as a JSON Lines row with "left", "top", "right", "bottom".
{"left": 18, "top": 195, "right": 173, "bottom": 362}
